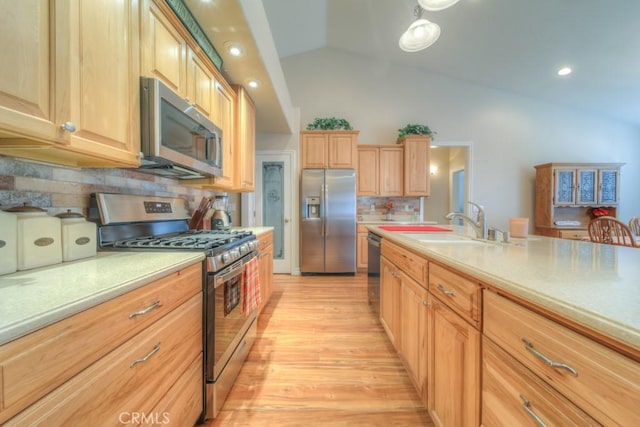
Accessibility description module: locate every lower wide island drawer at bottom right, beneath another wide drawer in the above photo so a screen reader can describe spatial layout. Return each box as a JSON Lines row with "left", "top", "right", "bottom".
{"left": 482, "top": 337, "right": 599, "bottom": 427}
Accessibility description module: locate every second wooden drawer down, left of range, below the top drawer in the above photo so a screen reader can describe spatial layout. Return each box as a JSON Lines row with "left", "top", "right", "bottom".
{"left": 7, "top": 293, "right": 202, "bottom": 427}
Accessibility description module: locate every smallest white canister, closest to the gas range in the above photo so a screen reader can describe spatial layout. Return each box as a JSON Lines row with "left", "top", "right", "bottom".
{"left": 56, "top": 210, "right": 97, "bottom": 261}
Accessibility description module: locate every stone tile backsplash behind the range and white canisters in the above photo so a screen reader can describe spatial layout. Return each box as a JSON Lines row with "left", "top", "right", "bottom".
{"left": 0, "top": 156, "right": 216, "bottom": 215}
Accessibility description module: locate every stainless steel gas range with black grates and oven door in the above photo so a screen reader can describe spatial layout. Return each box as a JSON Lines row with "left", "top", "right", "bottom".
{"left": 90, "top": 193, "right": 258, "bottom": 418}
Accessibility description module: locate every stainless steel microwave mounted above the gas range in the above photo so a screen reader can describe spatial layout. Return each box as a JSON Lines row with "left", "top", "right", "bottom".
{"left": 140, "top": 77, "right": 223, "bottom": 179}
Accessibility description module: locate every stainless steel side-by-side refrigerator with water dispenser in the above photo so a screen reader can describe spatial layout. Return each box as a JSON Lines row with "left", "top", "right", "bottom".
{"left": 300, "top": 169, "right": 356, "bottom": 274}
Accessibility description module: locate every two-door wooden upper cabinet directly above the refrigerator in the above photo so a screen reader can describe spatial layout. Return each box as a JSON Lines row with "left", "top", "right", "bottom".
{"left": 300, "top": 130, "right": 360, "bottom": 169}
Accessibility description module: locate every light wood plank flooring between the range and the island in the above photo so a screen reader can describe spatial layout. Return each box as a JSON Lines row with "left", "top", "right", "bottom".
{"left": 205, "top": 274, "right": 433, "bottom": 427}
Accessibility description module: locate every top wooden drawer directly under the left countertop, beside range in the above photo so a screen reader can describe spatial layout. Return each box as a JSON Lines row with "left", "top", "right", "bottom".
{"left": 0, "top": 263, "right": 202, "bottom": 423}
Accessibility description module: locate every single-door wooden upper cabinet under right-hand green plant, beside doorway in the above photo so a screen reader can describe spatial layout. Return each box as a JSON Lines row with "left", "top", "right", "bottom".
{"left": 398, "top": 135, "right": 431, "bottom": 196}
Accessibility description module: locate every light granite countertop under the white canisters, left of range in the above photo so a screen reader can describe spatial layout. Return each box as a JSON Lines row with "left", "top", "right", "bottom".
{"left": 0, "top": 251, "right": 204, "bottom": 345}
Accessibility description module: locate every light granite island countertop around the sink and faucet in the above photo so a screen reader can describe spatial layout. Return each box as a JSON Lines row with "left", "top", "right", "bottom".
{"left": 368, "top": 225, "right": 640, "bottom": 350}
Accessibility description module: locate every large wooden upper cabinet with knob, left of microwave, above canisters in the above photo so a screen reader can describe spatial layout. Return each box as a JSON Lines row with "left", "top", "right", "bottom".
{"left": 0, "top": 0, "right": 140, "bottom": 167}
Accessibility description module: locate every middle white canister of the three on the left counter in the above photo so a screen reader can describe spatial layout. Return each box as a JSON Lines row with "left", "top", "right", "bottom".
{"left": 7, "top": 203, "right": 62, "bottom": 270}
